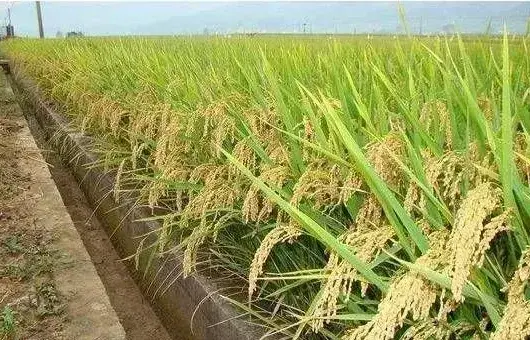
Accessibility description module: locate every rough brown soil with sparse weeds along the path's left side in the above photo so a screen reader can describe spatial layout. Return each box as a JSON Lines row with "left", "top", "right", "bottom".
{"left": 0, "top": 79, "right": 68, "bottom": 340}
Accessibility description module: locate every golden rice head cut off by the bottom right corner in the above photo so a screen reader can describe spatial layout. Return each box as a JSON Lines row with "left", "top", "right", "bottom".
{"left": 491, "top": 250, "right": 530, "bottom": 340}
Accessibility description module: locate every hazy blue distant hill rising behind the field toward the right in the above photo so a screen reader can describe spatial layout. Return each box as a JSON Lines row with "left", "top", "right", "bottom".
{"left": 134, "top": 2, "right": 530, "bottom": 34}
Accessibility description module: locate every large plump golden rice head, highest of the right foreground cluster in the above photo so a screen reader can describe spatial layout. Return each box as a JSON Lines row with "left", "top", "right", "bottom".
{"left": 448, "top": 183, "right": 508, "bottom": 301}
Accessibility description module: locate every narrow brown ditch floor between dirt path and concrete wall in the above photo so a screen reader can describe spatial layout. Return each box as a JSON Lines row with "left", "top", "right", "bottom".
{"left": 19, "top": 93, "right": 172, "bottom": 340}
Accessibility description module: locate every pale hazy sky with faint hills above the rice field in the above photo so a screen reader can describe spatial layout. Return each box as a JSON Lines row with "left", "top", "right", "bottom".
{"left": 0, "top": 1, "right": 530, "bottom": 37}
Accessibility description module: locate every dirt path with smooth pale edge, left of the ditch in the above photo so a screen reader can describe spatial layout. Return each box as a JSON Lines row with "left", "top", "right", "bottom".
{"left": 0, "top": 74, "right": 125, "bottom": 340}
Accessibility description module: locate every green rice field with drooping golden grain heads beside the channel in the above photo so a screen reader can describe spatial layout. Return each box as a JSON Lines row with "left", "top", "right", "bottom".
{"left": 0, "top": 34, "right": 530, "bottom": 340}
